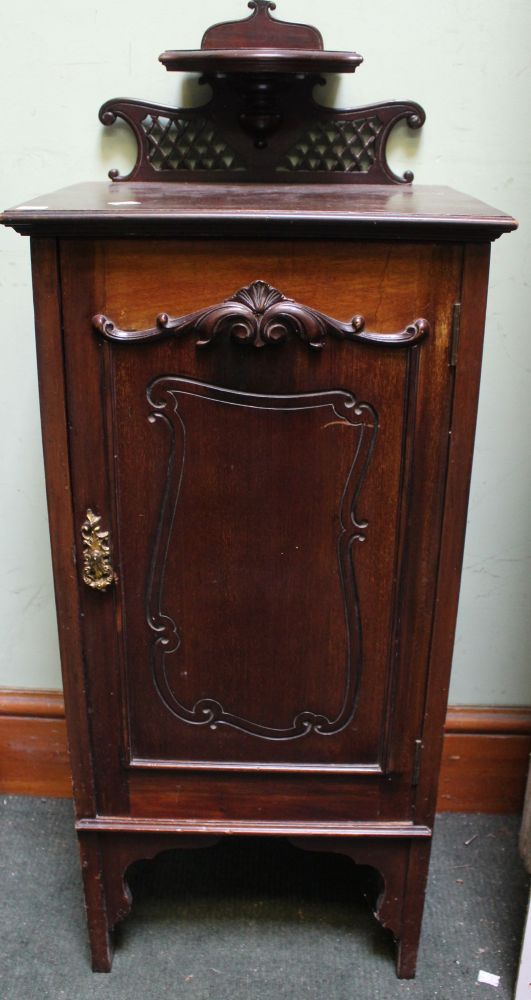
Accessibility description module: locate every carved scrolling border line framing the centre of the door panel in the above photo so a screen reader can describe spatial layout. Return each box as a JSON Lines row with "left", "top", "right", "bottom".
{"left": 146, "top": 375, "right": 378, "bottom": 741}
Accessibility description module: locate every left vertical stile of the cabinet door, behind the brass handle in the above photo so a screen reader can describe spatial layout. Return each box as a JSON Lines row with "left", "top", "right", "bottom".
{"left": 60, "top": 241, "right": 128, "bottom": 812}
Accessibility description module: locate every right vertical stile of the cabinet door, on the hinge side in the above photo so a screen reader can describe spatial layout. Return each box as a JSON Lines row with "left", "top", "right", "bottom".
{"left": 380, "top": 245, "right": 462, "bottom": 796}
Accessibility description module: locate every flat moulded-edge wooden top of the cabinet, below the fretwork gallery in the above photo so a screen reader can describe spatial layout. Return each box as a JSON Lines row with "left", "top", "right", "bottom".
{"left": 0, "top": 182, "right": 517, "bottom": 240}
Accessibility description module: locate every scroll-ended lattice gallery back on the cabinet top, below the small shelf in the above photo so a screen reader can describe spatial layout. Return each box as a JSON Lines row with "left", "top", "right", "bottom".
{"left": 99, "top": 90, "right": 420, "bottom": 186}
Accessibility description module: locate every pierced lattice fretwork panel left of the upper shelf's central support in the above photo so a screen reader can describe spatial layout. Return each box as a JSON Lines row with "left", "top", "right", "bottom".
{"left": 140, "top": 115, "right": 245, "bottom": 171}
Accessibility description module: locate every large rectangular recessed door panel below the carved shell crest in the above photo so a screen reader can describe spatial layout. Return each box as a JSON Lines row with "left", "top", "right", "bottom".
{"left": 111, "top": 336, "right": 413, "bottom": 769}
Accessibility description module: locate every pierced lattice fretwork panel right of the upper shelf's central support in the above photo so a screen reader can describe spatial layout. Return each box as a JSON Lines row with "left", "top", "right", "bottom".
{"left": 277, "top": 115, "right": 383, "bottom": 173}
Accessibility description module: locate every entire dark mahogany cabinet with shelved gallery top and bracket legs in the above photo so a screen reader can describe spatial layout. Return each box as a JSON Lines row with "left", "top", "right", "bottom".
{"left": 3, "top": 3, "right": 515, "bottom": 977}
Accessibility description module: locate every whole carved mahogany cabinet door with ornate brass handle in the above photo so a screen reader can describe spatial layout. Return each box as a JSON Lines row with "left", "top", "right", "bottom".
{"left": 62, "top": 241, "right": 460, "bottom": 818}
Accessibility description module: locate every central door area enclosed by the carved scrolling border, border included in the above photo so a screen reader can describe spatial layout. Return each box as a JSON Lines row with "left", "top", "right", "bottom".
{"left": 147, "top": 376, "right": 377, "bottom": 747}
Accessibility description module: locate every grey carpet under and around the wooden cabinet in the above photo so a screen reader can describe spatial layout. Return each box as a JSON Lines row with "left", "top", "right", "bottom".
{"left": 0, "top": 797, "right": 527, "bottom": 1000}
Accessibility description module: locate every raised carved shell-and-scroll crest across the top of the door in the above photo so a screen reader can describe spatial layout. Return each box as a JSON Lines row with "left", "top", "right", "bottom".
{"left": 92, "top": 280, "right": 430, "bottom": 350}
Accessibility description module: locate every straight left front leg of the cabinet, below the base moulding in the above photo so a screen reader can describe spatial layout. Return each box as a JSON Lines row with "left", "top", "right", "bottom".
{"left": 79, "top": 836, "right": 113, "bottom": 972}
